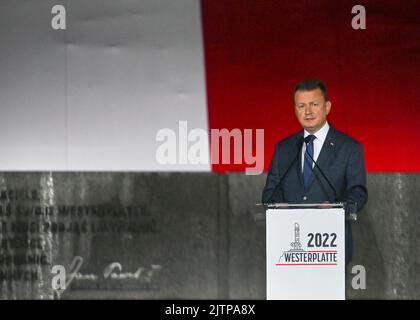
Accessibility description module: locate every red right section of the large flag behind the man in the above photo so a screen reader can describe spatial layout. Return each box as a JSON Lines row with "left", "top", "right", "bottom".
{"left": 202, "top": 0, "right": 420, "bottom": 172}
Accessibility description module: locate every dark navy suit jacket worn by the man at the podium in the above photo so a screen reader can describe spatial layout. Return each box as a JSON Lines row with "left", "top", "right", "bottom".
{"left": 262, "top": 125, "right": 368, "bottom": 262}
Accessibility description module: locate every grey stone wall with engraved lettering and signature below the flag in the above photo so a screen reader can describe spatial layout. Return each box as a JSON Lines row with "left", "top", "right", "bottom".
{"left": 0, "top": 173, "right": 420, "bottom": 299}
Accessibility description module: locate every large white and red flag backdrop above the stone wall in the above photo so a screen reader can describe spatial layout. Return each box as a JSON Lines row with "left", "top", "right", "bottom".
{"left": 0, "top": 0, "right": 420, "bottom": 172}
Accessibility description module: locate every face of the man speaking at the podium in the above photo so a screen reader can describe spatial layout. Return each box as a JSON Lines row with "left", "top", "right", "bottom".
{"left": 295, "top": 89, "right": 331, "bottom": 134}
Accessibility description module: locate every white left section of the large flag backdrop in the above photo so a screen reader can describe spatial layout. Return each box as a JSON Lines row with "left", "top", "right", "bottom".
{"left": 0, "top": 0, "right": 210, "bottom": 172}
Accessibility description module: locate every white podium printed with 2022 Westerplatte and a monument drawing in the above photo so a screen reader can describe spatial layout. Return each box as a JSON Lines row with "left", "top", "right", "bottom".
{"left": 265, "top": 203, "right": 345, "bottom": 300}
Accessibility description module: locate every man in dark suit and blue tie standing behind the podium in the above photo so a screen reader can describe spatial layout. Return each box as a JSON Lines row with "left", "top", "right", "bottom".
{"left": 262, "top": 79, "right": 368, "bottom": 263}
